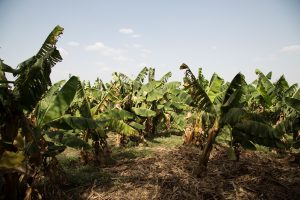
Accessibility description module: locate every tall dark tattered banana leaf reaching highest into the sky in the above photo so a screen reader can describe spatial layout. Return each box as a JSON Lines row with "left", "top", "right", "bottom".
{"left": 13, "top": 26, "right": 63, "bottom": 111}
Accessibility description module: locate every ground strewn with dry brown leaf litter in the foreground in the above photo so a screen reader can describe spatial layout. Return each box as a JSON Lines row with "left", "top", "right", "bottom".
{"left": 50, "top": 138, "right": 300, "bottom": 200}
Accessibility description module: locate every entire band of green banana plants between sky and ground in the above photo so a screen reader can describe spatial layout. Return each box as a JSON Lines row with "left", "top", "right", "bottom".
{"left": 0, "top": 26, "right": 300, "bottom": 199}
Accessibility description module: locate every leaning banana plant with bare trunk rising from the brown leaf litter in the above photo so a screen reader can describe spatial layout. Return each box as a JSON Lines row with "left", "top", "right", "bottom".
{"left": 181, "top": 64, "right": 283, "bottom": 175}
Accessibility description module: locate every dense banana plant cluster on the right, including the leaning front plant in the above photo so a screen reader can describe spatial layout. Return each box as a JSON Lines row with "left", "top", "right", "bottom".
{"left": 180, "top": 64, "right": 300, "bottom": 175}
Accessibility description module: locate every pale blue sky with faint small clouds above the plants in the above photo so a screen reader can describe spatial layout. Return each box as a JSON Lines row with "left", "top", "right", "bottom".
{"left": 0, "top": 0, "right": 300, "bottom": 83}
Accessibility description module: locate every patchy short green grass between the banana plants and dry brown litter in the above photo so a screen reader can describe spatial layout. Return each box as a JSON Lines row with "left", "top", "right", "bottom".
{"left": 54, "top": 135, "right": 182, "bottom": 187}
